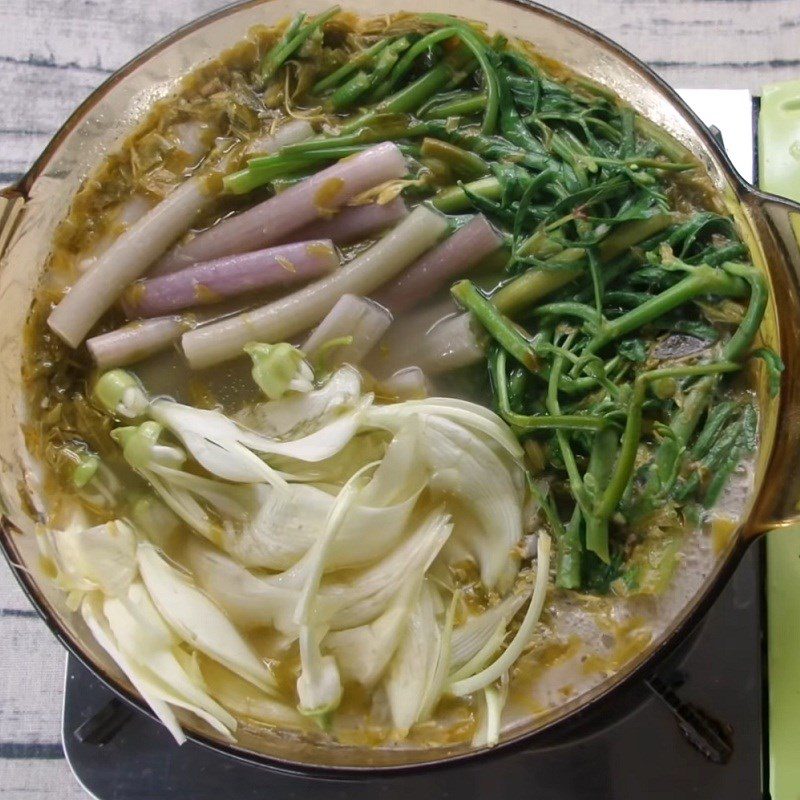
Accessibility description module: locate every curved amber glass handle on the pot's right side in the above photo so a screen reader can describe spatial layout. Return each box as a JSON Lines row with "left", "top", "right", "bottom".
{"left": 743, "top": 190, "right": 800, "bottom": 539}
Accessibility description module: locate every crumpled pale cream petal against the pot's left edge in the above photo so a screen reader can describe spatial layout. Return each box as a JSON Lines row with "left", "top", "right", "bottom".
{"left": 36, "top": 520, "right": 137, "bottom": 608}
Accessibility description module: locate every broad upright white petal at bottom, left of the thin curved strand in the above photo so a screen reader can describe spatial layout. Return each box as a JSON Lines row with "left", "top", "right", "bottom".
{"left": 383, "top": 580, "right": 442, "bottom": 739}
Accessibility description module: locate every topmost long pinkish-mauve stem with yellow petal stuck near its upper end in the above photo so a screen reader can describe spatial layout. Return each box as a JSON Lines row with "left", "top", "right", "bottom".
{"left": 152, "top": 142, "right": 406, "bottom": 272}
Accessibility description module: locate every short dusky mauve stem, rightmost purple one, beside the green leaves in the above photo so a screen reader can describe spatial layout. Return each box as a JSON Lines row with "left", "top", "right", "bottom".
{"left": 375, "top": 214, "right": 503, "bottom": 314}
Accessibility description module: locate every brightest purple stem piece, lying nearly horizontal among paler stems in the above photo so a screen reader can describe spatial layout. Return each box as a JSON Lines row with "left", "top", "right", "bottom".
{"left": 123, "top": 239, "right": 339, "bottom": 317}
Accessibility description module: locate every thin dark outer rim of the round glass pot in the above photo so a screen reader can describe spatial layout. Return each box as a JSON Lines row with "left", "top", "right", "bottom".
{"left": 0, "top": 0, "right": 788, "bottom": 781}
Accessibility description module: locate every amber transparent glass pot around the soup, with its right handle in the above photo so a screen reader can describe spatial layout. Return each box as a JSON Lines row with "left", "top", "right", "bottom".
{"left": 0, "top": 0, "right": 800, "bottom": 776}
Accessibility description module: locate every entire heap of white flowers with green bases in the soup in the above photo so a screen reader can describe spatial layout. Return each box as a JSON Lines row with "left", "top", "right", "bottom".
{"left": 76, "top": 356, "right": 550, "bottom": 745}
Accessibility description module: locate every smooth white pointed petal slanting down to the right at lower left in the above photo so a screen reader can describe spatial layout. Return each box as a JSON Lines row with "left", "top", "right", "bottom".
{"left": 137, "top": 543, "right": 277, "bottom": 692}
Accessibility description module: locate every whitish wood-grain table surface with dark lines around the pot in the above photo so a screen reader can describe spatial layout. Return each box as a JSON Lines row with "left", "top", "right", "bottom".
{"left": 0, "top": 0, "right": 800, "bottom": 800}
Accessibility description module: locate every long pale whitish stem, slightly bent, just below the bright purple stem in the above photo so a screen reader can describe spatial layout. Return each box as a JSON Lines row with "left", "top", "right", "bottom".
{"left": 182, "top": 205, "right": 447, "bottom": 369}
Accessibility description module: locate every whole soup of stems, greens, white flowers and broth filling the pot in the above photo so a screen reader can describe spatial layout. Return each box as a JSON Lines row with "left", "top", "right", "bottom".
{"left": 25, "top": 8, "right": 782, "bottom": 747}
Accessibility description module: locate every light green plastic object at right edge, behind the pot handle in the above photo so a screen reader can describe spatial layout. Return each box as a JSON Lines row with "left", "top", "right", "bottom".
{"left": 758, "top": 80, "right": 800, "bottom": 800}
